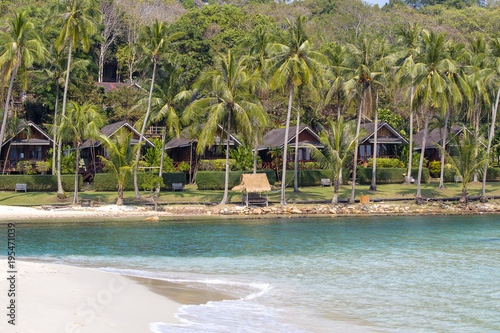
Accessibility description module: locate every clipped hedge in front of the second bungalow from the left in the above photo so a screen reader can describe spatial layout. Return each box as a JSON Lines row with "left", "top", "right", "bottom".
{"left": 94, "top": 172, "right": 186, "bottom": 192}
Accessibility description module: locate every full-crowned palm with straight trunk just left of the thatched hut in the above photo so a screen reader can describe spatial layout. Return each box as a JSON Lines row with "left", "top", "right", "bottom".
{"left": 184, "top": 51, "right": 268, "bottom": 204}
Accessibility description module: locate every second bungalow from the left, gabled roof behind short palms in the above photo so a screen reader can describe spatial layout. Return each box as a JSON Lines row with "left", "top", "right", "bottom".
{"left": 80, "top": 120, "right": 154, "bottom": 181}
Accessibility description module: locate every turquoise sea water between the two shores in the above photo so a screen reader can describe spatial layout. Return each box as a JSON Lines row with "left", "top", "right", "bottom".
{"left": 2, "top": 215, "right": 500, "bottom": 332}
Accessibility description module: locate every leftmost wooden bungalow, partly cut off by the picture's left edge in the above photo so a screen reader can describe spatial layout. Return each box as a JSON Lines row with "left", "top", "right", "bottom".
{"left": 0, "top": 121, "right": 54, "bottom": 173}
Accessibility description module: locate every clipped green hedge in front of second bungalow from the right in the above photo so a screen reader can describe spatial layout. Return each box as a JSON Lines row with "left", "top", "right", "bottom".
{"left": 356, "top": 168, "right": 429, "bottom": 185}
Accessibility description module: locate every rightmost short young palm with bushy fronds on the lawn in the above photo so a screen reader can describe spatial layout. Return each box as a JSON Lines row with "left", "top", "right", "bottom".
{"left": 438, "top": 127, "right": 488, "bottom": 203}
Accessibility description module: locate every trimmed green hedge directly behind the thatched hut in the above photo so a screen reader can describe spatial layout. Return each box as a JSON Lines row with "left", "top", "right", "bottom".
{"left": 196, "top": 170, "right": 276, "bottom": 190}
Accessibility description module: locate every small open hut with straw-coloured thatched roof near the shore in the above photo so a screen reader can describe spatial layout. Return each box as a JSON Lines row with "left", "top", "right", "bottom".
{"left": 233, "top": 173, "right": 271, "bottom": 207}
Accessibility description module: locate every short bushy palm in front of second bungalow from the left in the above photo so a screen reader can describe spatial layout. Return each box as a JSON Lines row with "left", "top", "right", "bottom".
{"left": 100, "top": 128, "right": 139, "bottom": 205}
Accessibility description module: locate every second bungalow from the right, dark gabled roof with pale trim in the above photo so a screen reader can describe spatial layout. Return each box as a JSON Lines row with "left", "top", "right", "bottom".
{"left": 358, "top": 121, "right": 409, "bottom": 164}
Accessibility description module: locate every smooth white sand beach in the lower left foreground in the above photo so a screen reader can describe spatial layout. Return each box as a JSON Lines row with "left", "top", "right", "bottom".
{"left": 0, "top": 260, "right": 181, "bottom": 333}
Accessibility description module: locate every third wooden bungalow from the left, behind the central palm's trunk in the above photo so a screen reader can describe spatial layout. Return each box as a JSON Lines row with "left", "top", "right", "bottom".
{"left": 165, "top": 125, "right": 241, "bottom": 169}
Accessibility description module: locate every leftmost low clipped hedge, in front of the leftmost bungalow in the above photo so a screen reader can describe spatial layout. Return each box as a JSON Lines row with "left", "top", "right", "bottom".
{"left": 0, "top": 175, "right": 83, "bottom": 192}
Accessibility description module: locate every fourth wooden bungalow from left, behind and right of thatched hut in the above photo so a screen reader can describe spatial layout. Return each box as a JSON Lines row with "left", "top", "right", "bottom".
{"left": 258, "top": 125, "right": 323, "bottom": 169}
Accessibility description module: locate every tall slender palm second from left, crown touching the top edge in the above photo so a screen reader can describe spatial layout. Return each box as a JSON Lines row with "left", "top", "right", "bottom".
{"left": 52, "top": 0, "right": 101, "bottom": 198}
